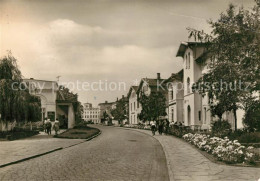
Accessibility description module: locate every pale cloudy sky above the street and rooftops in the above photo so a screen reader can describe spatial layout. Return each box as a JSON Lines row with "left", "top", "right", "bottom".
{"left": 0, "top": 0, "right": 254, "bottom": 105}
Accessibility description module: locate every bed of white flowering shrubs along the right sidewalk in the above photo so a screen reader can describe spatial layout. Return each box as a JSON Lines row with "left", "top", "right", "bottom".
{"left": 183, "top": 133, "right": 258, "bottom": 163}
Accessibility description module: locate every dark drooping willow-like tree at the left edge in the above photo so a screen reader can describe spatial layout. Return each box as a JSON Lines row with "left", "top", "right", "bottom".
{"left": 0, "top": 52, "right": 41, "bottom": 123}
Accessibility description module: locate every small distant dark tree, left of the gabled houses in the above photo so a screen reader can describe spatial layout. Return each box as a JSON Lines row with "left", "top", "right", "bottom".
{"left": 111, "top": 98, "right": 128, "bottom": 124}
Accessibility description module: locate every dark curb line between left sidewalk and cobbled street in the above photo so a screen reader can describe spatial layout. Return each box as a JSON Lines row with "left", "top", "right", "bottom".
{"left": 0, "top": 130, "right": 102, "bottom": 168}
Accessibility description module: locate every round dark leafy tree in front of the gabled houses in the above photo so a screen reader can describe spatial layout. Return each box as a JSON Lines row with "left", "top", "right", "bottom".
{"left": 138, "top": 91, "right": 167, "bottom": 122}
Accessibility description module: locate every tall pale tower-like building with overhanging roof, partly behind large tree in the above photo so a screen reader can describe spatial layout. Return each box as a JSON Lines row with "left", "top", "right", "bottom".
{"left": 176, "top": 42, "right": 243, "bottom": 129}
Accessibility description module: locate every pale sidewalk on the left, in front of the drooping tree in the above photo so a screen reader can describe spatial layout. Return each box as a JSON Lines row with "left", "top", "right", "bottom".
{"left": 0, "top": 130, "right": 86, "bottom": 166}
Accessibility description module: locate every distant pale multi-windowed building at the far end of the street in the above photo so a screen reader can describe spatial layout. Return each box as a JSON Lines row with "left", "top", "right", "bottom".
{"left": 82, "top": 103, "right": 100, "bottom": 124}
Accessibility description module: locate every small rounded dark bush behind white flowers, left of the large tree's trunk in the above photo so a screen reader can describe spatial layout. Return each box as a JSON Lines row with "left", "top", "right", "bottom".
{"left": 212, "top": 120, "right": 231, "bottom": 138}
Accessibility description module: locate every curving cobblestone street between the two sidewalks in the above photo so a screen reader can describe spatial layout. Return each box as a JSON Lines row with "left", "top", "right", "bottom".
{"left": 0, "top": 126, "right": 168, "bottom": 181}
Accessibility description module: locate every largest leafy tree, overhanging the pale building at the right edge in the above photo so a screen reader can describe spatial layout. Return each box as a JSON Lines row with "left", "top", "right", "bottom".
{"left": 188, "top": 0, "right": 260, "bottom": 130}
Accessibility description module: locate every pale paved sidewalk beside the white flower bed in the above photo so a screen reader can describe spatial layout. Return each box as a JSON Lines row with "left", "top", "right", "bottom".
{"left": 123, "top": 129, "right": 260, "bottom": 181}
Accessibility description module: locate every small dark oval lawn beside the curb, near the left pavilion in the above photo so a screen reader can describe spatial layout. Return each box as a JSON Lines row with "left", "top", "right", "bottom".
{"left": 55, "top": 127, "right": 100, "bottom": 139}
